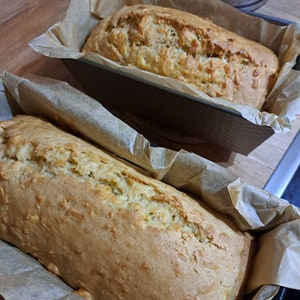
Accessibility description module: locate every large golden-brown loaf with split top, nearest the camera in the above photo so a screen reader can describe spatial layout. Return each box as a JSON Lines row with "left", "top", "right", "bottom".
{"left": 0, "top": 116, "right": 253, "bottom": 300}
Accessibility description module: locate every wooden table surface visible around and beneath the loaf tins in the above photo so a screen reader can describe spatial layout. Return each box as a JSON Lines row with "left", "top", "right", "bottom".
{"left": 0, "top": 0, "right": 300, "bottom": 188}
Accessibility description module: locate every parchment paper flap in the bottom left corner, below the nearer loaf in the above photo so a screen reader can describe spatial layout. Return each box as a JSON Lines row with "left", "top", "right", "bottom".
{"left": 0, "top": 240, "right": 87, "bottom": 300}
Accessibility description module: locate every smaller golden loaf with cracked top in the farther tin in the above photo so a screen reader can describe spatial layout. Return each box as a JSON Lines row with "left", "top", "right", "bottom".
{"left": 82, "top": 5, "right": 278, "bottom": 109}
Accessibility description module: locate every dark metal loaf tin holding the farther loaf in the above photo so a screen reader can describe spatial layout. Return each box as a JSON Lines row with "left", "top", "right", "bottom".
{"left": 62, "top": 12, "right": 298, "bottom": 155}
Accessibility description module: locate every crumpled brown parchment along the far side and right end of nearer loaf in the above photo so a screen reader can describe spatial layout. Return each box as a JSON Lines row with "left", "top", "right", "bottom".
{"left": 3, "top": 72, "right": 300, "bottom": 300}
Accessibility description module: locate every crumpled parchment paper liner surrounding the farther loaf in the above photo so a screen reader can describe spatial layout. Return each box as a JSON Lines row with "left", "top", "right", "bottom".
{"left": 30, "top": 0, "right": 300, "bottom": 132}
